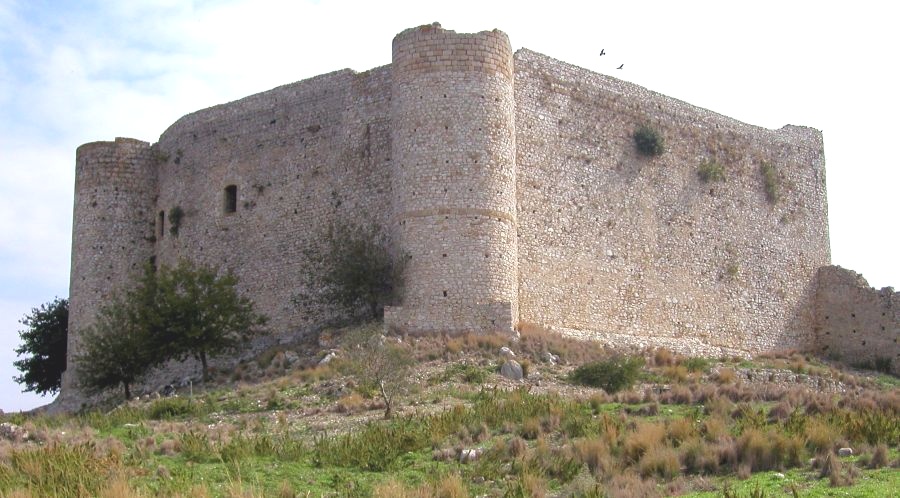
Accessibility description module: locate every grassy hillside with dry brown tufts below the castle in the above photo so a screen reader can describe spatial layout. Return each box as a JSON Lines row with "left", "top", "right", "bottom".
{"left": 0, "top": 322, "right": 900, "bottom": 498}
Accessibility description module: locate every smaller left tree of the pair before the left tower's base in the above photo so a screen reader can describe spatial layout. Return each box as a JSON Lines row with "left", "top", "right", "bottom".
{"left": 75, "top": 291, "right": 160, "bottom": 399}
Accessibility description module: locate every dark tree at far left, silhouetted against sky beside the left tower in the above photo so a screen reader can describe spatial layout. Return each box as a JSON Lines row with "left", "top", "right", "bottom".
{"left": 13, "top": 298, "right": 69, "bottom": 394}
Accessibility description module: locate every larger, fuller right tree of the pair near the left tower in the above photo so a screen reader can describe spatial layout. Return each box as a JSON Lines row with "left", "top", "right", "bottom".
{"left": 147, "top": 261, "right": 267, "bottom": 380}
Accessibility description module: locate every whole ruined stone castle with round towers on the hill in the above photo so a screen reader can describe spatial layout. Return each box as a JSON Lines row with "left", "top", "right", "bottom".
{"left": 63, "top": 24, "right": 900, "bottom": 393}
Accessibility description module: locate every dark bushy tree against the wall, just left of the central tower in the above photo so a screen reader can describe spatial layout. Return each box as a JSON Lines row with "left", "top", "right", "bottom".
{"left": 294, "top": 223, "right": 403, "bottom": 319}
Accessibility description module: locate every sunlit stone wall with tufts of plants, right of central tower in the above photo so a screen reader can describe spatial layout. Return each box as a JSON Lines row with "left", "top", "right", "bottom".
{"left": 515, "top": 50, "right": 830, "bottom": 354}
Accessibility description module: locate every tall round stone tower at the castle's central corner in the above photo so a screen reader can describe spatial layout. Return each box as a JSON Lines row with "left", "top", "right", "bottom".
{"left": 385, "top": 23, "right": 518, "bottom": 332}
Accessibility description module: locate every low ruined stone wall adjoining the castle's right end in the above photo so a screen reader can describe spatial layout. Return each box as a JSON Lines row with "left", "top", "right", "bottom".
{"left": 816, "top": 266, "right": 900, "bottom": 374}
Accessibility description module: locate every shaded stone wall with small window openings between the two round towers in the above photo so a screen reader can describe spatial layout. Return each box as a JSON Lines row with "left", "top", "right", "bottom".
{"left": 149, "top": 67, "right": 391, "bottom": 333}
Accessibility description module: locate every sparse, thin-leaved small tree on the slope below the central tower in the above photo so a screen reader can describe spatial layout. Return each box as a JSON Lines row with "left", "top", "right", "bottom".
{"left": 342, "top": 323, "right": 413, "bottom": 418}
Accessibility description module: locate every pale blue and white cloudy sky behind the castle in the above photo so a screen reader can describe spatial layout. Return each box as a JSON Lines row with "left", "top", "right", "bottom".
{"left": 0, "top": 0, "right": 900, "bottom": 411}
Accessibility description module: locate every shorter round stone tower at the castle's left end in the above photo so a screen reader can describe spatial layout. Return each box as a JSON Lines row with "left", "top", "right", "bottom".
{"left": 62, "top": 138, "right": 157, "bottom": 397}
